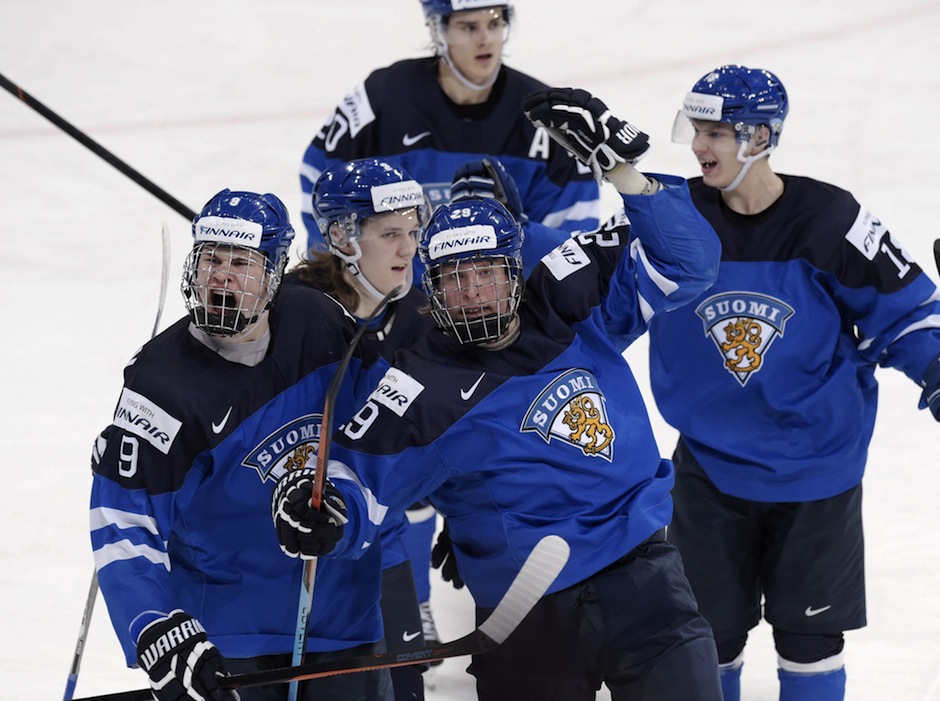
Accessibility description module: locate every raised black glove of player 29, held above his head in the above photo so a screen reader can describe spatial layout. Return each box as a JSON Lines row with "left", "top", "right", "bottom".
{"left": 522, "top": 88, "right": 649, "bottom": 178}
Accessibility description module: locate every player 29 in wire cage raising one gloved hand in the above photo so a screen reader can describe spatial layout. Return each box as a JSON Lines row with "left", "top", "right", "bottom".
{"left": 272, "top": 89, "right": 720, "bottom": 701}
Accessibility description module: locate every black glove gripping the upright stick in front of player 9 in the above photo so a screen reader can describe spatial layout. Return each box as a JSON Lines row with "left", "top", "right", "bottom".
{"left": 271, "top": 467, "right": 346, "bottom": 560}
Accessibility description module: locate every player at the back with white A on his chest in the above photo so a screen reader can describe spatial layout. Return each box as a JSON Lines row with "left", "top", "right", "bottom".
{"left": 300, "top": 0, "right": 600, "bottom": 249}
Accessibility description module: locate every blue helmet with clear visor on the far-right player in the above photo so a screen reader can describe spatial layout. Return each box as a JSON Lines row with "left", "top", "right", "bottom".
{"left": 673, "top": 65, "right": 790, "bottom": 147}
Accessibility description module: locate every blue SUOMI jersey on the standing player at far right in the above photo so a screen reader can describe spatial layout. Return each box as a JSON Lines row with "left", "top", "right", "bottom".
{"left": 650, "top": 176, "right": 940, "bottom": 502}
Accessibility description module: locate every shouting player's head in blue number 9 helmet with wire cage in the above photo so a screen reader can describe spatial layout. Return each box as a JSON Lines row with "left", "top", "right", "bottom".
{"left": 180, "top": 189, "right": 294, "bottom": 336}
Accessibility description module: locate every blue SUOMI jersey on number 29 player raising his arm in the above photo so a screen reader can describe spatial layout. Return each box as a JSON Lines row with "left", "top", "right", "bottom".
{"left": 318, "top": 176, "right": 719, "bottom": 606}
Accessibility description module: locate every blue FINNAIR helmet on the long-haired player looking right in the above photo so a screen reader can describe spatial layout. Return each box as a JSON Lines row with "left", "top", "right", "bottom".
{"left": 311, "top": 158, "right": 430, "bottom": 263}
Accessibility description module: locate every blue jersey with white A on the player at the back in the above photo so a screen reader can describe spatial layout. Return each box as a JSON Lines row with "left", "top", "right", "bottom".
{"left": 300, "top": 56, "right": 600, "bottom": 247}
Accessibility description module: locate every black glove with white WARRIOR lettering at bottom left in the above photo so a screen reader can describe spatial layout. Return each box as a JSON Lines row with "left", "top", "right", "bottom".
{"left": 137, "top": 609, "right": 238, "bottom": 701}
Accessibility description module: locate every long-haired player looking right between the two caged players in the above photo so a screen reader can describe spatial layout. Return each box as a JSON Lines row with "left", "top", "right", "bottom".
{"left": 284, "top": 158, "right": 433, "bottom": 701}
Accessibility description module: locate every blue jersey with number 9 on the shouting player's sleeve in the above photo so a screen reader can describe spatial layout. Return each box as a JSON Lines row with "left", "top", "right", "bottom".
{"left": 91, "top": 286, "right": 388, "bottom": 665}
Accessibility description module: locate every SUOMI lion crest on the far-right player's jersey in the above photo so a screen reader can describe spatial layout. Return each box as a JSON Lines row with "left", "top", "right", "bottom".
{"left": 695, "top": 292, "right": 794, "bottom": 387}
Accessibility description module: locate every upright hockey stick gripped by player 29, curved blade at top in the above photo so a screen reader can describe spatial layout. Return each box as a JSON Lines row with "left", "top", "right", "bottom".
{"left": 287, "top": 287, "right": 401, "bottom": 701}
